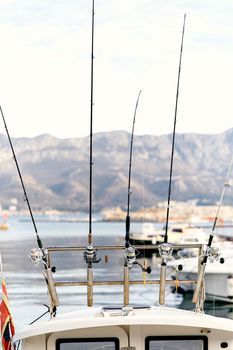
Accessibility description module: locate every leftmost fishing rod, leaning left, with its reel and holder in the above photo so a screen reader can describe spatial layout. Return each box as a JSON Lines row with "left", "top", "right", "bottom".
{"left": 0, "top": 106, "right": 59, "bottom": 316}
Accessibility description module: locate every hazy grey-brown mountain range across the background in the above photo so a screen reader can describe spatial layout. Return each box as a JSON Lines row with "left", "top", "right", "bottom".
{"left": 0, "top": 129, "right": 233, "bottom": 211}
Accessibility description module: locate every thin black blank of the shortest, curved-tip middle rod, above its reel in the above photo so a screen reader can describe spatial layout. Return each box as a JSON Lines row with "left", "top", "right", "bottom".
{"left": 125, "top": 90, "right": 142, "bottom": 248}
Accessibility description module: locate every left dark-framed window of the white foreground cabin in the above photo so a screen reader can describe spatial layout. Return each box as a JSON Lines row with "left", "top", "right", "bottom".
{"left": 56, "top": 338, "right": 119, "bottom": 350}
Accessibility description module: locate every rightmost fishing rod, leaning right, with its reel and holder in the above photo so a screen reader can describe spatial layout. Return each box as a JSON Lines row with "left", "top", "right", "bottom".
{"left": 193, "top": 155, "right": 233, "bottom": 304}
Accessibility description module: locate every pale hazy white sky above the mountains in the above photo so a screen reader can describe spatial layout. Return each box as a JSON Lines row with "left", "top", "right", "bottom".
{"left": 0, "top": 0, "right": 233, "bottom": 137}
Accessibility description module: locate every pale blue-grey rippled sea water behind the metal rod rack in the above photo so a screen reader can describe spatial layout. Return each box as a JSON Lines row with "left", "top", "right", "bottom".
{"left": 0, "top": 214, "right": 233, "bottom": 330}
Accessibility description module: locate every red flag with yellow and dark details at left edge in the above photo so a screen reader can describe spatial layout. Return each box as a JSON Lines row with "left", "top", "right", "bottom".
{"left": 0, "top": 278, "right": 15, "bottom": 350}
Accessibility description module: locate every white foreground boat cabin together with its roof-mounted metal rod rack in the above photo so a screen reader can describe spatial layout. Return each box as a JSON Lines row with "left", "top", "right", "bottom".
{"left": 11, "top": 241, "right": 233, "bottom": 350}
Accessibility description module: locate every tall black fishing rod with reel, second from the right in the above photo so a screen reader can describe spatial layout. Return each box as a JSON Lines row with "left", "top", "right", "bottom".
{"left": 159, "top": 14, "right": 186, "bottom": 304}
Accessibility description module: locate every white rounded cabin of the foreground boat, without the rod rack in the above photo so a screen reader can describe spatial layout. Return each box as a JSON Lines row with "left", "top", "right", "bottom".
{"left": 15, "top": 300, "right": 233, "bottom": 350}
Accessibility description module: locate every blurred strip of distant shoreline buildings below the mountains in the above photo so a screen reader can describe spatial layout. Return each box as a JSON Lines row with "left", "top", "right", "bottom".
{"left": 8, "top": 202, "right": 233, "bottom": 225}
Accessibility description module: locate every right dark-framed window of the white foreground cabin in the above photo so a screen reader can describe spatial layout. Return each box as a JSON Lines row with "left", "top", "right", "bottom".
{"left": 146, "top": 336, "right": 208, "bottom": 350}
